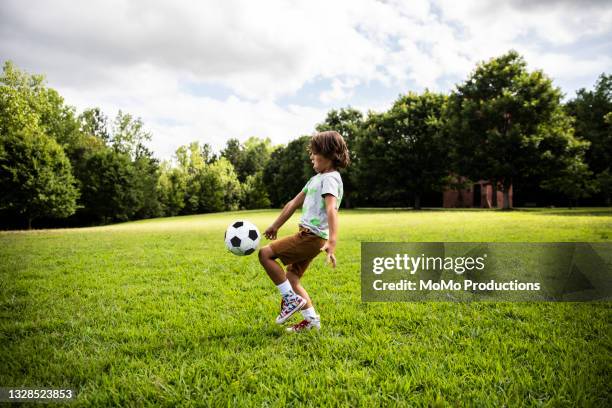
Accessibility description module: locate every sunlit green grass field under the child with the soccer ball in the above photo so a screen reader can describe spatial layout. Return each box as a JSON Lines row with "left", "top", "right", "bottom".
{"left": 0, "top": 209, "right": 612, "bottom": 407}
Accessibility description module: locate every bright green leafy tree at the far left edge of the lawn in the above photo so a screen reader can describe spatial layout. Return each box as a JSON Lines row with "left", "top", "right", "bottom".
{"left": 0, "top": 62, "right": 78, "bottom": 229}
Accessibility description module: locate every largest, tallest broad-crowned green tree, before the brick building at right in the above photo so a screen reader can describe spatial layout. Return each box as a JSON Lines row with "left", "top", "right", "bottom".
{"left": 445, "top": 51, "right": 588, "bottom": 209}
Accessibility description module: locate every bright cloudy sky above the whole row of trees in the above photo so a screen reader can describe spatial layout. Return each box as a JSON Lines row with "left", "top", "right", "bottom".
{"left": 0, "top": 0, "right": 612, "bottom": 158}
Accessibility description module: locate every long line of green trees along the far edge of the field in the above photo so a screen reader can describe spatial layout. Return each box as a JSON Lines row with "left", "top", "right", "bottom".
{"left": 0, "top": 51, "right": 612, "bottom": 228}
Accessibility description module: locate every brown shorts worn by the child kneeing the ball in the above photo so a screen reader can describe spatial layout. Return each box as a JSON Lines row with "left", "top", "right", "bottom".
{"left": 269, "top": 226, "right": 326, "bottom": 277}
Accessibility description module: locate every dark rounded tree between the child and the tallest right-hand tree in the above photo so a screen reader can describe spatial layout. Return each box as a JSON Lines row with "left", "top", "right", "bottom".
{"left": 358, "top": 91, "right": 449, "bottom": 209}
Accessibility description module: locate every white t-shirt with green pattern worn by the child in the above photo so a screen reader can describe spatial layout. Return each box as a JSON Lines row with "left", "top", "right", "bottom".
{"left": 300, "top": 171, "right": 344, "bottom": 239}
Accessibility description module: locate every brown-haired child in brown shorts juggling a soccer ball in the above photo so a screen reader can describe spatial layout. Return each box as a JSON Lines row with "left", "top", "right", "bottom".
{"left": 259, "top": 131, "right": 349, "bottom": 332}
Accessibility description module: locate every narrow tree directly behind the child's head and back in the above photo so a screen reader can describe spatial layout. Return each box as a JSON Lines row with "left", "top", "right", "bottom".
{"left": 316, "top": 107, "right": 364, "bottom": 208}
